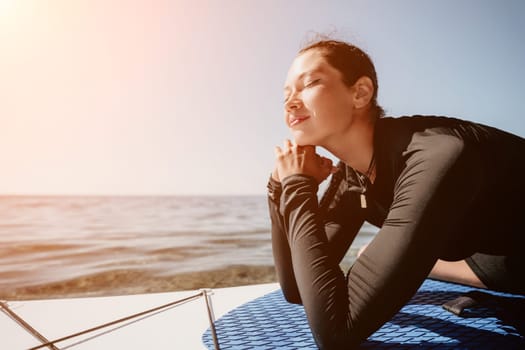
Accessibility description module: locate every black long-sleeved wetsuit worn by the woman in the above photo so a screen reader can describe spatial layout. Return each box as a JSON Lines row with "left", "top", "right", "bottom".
{"left": 268, "top": 116, "right": 525, "bottom": 349}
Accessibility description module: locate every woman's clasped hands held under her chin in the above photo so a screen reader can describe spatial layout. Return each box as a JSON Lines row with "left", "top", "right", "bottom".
{"left": 272, "top": 140, "right": 337, "bottom": 184}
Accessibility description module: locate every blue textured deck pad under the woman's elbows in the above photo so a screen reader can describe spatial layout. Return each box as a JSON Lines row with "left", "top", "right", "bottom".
{"left": 203, "top": 279, "right": 525, "bottom": 350}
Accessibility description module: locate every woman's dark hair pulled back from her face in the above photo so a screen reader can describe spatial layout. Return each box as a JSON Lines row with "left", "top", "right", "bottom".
{"left": 299, "top": 40, "right": 385, "bottom": 119}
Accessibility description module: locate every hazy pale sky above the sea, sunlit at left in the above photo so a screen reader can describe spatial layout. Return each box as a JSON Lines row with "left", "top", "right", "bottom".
{"left": 0, "top": 0, "right": 525, "bottom": 195}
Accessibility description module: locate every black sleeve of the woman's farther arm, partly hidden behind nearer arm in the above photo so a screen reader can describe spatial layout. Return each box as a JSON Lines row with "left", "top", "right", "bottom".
{"left": 268, "top": 175, "right": 364, "bottom": 304}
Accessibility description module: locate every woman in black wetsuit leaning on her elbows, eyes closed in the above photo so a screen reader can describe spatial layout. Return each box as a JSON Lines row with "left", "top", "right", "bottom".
{"left": 268, "top": 40, "right": 525, "bottom": 349}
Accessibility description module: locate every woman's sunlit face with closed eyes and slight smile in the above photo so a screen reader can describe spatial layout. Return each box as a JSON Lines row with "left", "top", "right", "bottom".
{"left": 284, "top": 49, "right": 354, "bottom": 147}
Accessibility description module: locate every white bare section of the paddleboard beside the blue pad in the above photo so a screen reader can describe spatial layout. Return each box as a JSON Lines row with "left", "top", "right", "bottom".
{"left": 0, "top": 283, "right": 279, "bottom": 350}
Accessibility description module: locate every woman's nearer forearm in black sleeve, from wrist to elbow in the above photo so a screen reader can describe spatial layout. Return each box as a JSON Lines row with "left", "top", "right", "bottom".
{"left": 280, "top": 176, "right": 356, "bottom": 348}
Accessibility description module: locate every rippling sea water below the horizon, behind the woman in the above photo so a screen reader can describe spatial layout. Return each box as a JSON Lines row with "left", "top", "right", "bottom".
{"left": 0, "top": 196, "right": 375, "bottom": 292}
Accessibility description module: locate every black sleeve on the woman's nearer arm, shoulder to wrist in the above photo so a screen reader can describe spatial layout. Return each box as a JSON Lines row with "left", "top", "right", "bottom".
{"left": 280, "top": 136, "right": 482, "bottom": 349}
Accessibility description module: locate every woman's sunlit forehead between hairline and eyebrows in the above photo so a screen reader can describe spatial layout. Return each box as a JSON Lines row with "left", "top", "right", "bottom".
{"left": 285, "top": 50, "right": 338, "bottom": 89}
